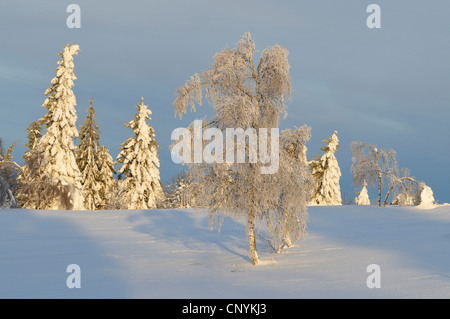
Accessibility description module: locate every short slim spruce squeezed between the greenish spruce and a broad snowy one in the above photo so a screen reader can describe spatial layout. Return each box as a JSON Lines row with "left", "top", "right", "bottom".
{"left": 98, "top": 145, "right": 117, "bottom": 209}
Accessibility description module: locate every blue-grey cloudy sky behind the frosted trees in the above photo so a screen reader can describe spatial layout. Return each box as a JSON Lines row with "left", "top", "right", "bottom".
{"left": 0, "top": 0, "right": 450, "bottom": 203}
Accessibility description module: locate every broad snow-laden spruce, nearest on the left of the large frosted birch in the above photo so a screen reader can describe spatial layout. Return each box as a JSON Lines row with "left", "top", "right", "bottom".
{"left": 115, "top": 98, "right": 164, "bottom": 209}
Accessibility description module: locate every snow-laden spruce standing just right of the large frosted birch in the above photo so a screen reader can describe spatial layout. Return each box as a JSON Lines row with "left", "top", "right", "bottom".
{"left": 309, "top": 131, "right": 342, "bottom": 205}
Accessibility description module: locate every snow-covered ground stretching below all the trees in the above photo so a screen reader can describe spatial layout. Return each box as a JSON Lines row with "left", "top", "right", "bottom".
{"left": 0, "top": 206, "right": 450, "bottom": 298}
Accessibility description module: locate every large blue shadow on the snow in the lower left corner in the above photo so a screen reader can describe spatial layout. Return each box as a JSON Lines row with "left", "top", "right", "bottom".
{"left": 0, "top": 209, "right": 130, "bottom": 299}
